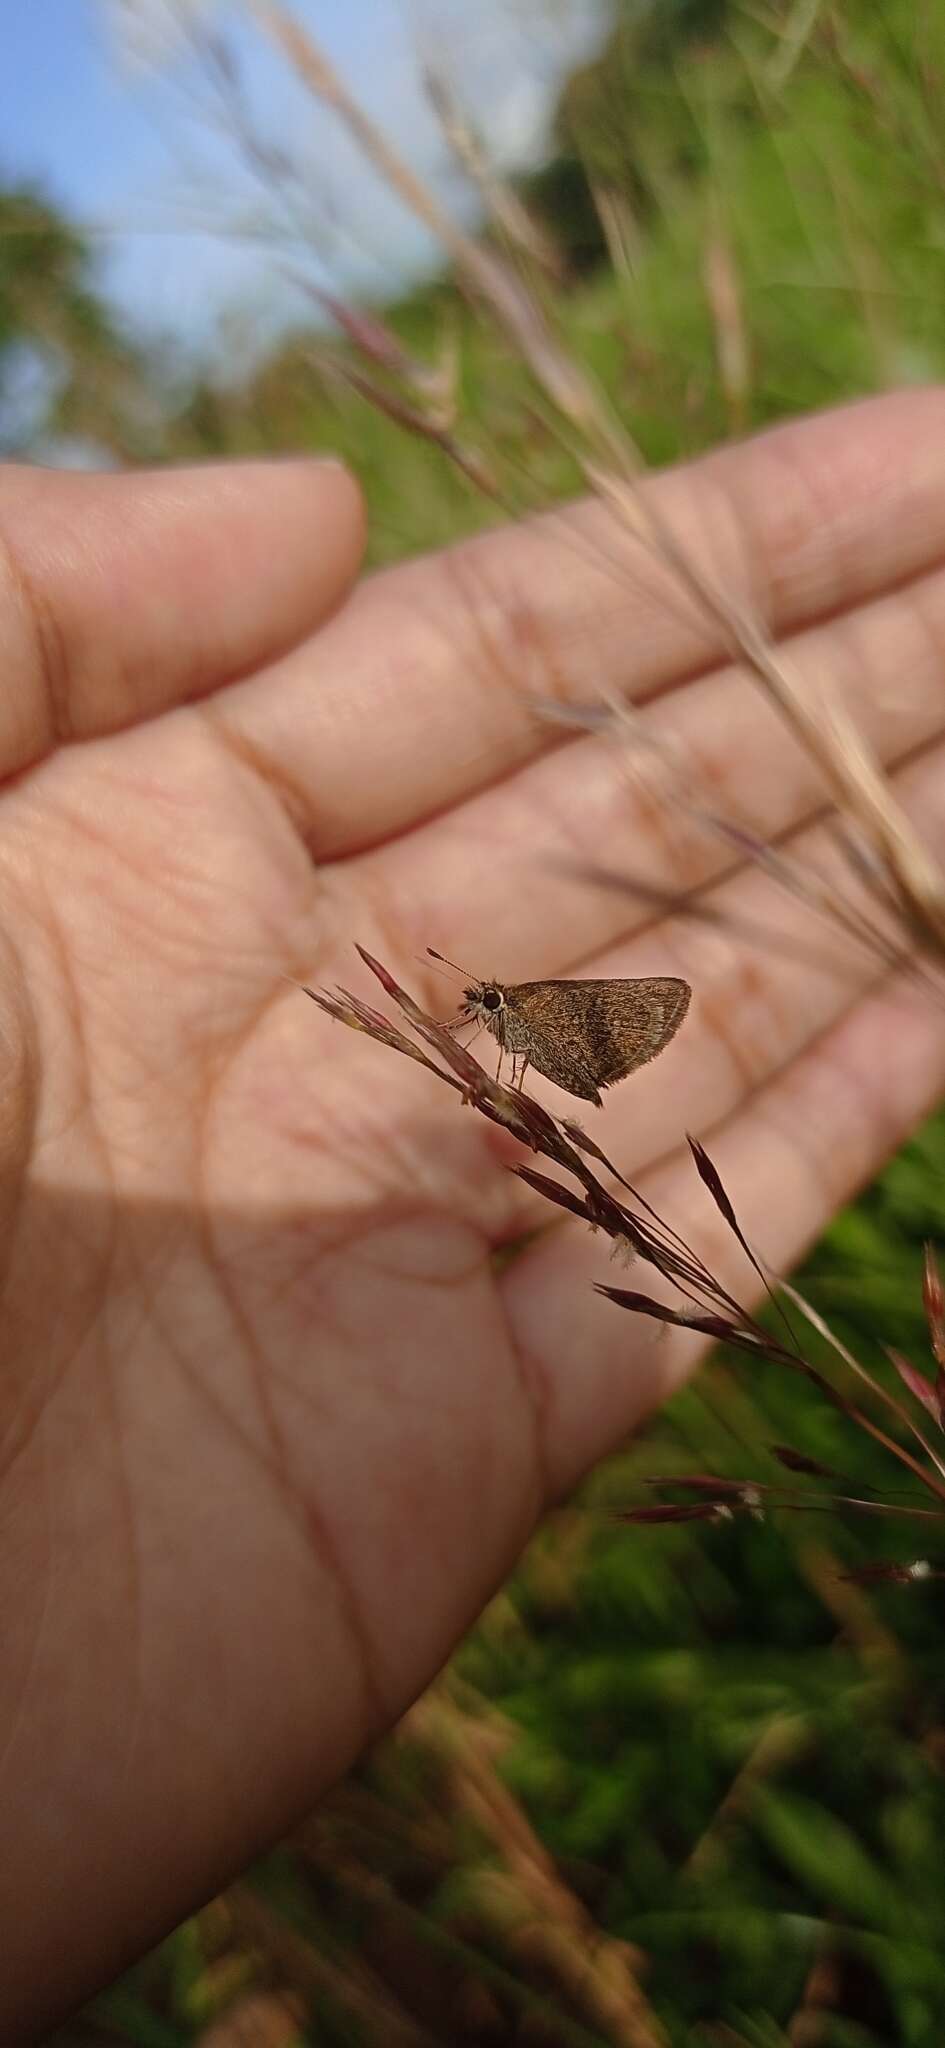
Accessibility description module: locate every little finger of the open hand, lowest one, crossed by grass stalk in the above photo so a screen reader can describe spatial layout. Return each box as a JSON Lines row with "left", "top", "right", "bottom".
{"left": 502, "top": 958, "right": 945, "bottom": 1499}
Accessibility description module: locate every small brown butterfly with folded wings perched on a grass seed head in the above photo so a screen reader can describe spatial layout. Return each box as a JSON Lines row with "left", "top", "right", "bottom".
{"left": 426, "top": 946, "right": 693, "bottom": 1108}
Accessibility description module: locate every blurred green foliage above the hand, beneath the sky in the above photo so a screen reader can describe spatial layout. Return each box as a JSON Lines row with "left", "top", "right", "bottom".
{"left": 12, "top": 0, "right": 945, "bottom": 544}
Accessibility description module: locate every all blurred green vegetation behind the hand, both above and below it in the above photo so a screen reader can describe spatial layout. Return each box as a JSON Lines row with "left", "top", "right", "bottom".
{"left": 11, "top": 0, "right": 945, "bottom": 2048}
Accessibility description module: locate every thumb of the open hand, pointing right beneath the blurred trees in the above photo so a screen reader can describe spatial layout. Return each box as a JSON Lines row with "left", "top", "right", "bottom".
{"left": 0, "top": 461, "right": 363, "bottom": 776}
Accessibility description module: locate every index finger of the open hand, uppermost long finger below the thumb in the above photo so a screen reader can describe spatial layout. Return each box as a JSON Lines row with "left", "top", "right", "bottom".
{"left": 215, "top": 391, "right": 945, "bottom": 860}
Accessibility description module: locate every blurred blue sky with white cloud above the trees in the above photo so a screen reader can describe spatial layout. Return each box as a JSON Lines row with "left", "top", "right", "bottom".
{"left": 0, "top": 0, "right": 607, "bottom": 354}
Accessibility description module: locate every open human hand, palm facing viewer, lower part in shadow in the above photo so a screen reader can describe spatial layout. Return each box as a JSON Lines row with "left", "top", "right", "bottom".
{"left": 0, "top": 391, "right": 945, "bottom": 2042}
